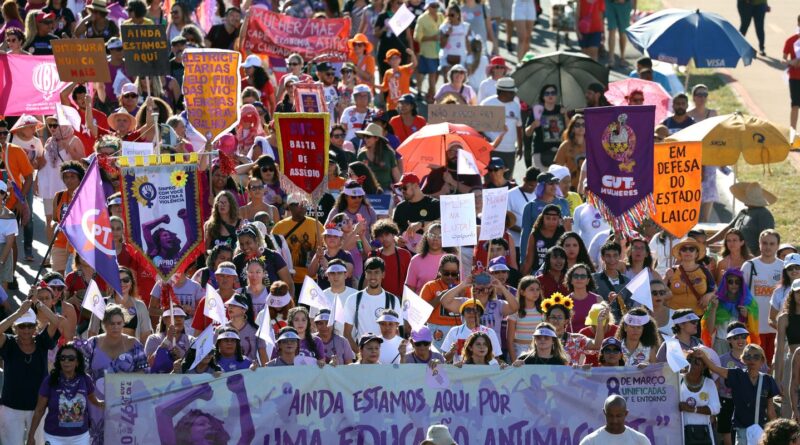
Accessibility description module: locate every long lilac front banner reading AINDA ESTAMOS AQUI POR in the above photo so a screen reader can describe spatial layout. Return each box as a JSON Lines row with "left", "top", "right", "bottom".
{"left": 105, "top": 364, "right": 683, "bottom": 445}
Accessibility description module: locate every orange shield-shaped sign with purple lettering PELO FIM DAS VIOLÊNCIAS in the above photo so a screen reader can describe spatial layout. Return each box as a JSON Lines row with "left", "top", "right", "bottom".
{"left": 183, "top": 49, "right": 241, "bottom": 141}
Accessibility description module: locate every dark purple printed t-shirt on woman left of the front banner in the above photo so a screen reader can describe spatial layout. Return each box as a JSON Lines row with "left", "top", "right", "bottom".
{"left": 39, "top": 375, "right": 94, "bottom": 437}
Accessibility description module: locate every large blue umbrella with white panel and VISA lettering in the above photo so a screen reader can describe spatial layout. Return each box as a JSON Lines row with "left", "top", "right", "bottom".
{"left": 627, "top": 9, "right": 756, "bottom": 68}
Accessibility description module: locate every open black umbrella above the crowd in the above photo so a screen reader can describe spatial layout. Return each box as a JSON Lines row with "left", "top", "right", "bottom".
{"left": 511, "top": 51, "right": 608, "bottom": 109}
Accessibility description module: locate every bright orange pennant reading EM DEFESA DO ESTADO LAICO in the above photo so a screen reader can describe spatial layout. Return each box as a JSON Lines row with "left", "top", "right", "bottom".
{"left": 652, "top": 142, "right": 703, "bottom": 238}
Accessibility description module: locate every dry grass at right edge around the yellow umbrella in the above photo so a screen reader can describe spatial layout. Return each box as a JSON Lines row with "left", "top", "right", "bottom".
{"left": 676, "top": 67, "right": 800, "bottom": 245}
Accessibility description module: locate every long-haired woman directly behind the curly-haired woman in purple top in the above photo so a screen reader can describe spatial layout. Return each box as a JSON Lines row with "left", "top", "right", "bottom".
{"left": 89, "top": 266, "right": 153, "bottom": 345}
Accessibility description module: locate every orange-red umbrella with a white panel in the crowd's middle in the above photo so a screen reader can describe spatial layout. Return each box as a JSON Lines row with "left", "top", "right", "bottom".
{"left": 397, "top": 122, "right": 493, "bottom": 178}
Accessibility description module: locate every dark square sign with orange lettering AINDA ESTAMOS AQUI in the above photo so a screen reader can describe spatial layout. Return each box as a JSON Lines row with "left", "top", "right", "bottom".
{"left": 122, "top": 25, "right": 170, "bottom": 76}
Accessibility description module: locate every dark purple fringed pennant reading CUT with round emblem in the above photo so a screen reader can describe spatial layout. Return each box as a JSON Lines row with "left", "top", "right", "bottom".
{"left": 584, "top": 105, "right": 655, "bottom": 233}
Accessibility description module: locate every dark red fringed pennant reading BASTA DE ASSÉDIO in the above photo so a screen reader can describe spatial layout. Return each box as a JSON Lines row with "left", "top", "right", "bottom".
{"left": 275, "top": 113, "right": 330, "bottom": 194}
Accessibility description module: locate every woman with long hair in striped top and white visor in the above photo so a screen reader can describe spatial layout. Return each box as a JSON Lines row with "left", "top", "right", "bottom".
{"left": 506, "top": 275, "right": 544, "bottom": 360}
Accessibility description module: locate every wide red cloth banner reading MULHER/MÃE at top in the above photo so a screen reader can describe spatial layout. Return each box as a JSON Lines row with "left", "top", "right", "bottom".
{"left": 244, "top": 6, "right": 350, "bottom": 62}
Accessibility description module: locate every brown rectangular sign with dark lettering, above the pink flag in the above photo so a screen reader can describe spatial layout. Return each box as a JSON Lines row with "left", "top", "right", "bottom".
{"left": 51, "top": 38, "right": 111, "bottom": 82}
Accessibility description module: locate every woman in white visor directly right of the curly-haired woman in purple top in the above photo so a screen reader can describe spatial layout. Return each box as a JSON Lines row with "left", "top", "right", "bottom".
{"left": 144, "top": 307, "right": 194, "bottom": 374}
